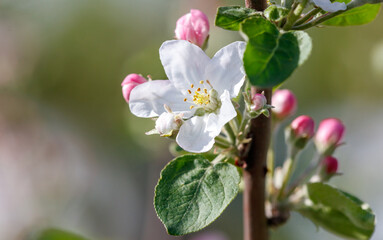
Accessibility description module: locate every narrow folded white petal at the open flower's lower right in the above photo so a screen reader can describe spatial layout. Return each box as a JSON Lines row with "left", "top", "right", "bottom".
{"left": 207, "top": 90, "right": 237, "bottom": 137}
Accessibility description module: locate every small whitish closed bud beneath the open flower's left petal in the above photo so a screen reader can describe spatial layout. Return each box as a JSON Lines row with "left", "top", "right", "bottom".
{"left": 155, "top": 112, "right": 183, "bottom": 137}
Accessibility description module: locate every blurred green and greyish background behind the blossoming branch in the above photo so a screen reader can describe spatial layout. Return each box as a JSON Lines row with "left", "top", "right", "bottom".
{"left": 0, "top": 0, "right": 383, "bottom": 240}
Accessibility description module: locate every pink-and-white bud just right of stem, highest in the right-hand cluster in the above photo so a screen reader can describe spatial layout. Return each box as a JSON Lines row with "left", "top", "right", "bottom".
{"left": 271, "top": 89, "right": 297, "bottom": 120}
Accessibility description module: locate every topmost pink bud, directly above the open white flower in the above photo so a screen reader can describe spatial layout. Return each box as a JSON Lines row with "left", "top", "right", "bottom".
{"left": 175, "top": 9, "right": 209, "bottom": 48}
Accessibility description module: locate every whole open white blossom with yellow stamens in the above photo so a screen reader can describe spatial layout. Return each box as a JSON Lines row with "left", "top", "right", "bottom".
{"left": 129, "top": 40, "right": 246, "bottom": 152}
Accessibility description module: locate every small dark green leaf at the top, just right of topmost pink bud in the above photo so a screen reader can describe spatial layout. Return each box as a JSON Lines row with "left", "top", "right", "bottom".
{"left": 215, "top": 6, "right": 259, "bottom": 31}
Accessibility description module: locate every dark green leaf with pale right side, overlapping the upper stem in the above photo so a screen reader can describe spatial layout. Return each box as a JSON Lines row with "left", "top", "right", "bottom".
{"left": 241, "top": 17, "right": 312, "bottom": 87}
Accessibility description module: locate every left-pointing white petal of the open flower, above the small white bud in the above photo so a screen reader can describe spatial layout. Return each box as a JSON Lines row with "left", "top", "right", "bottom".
{"left": 129, "top": 80, "right": 192, "bottom": 118}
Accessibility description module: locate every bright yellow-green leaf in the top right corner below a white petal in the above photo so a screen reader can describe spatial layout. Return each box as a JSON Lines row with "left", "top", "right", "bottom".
{"left": 323, "top": 0, "right": 380, "bottom": 26}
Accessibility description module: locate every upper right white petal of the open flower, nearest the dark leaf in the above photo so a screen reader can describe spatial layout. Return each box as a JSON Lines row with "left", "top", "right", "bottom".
{"left": 206, "top": 42, "right": 246, "bottom": 98}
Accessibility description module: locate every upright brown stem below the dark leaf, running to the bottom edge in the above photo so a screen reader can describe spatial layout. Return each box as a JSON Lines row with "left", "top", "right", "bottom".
{"left": 242, "top": 86, "right": 272, "bottom": 240}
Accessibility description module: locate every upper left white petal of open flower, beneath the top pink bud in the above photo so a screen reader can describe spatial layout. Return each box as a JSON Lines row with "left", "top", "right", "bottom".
{"left": 160, "top": 40, "right": 210, "bottom": 94}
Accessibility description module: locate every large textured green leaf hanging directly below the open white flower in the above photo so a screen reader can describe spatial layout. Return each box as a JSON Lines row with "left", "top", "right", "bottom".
{"left": 154, "top": 155, "right": 240, "bottom": 235}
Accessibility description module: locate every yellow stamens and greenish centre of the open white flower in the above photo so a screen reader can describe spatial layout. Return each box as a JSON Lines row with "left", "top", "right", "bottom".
{"left": 184, "top": 80, "right": 221, "bottom": 112}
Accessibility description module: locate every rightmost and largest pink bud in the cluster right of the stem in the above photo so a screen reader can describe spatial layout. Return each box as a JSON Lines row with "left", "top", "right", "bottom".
{"left": 315, "top": 118, "right": 345, "bottom": 155}
